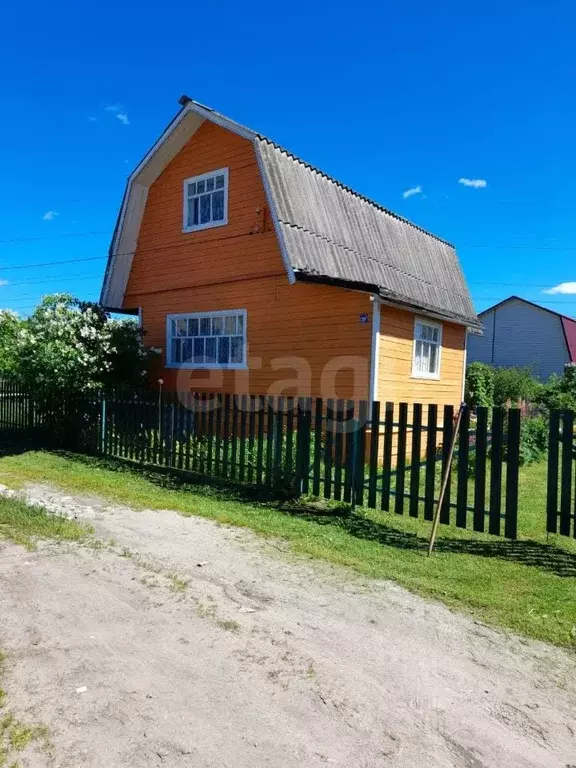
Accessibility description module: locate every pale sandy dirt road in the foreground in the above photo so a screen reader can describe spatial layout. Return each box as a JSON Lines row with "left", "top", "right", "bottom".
{"left": 0, "top": 487, "right": 576, "bottom": 768}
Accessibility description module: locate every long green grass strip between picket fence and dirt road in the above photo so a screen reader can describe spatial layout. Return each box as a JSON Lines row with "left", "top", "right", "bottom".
{"left": 0, "top": 452, "right": 576, "bottom": 648}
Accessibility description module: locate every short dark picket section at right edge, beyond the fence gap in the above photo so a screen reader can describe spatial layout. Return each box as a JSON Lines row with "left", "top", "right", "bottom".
{"left": 546, "top": 411, "right": 576, "bottom": 537}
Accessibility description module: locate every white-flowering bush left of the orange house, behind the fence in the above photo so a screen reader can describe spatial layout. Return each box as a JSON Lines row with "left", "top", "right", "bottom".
{"left": 0, "top": 294, "right": 160, "bottom": 394}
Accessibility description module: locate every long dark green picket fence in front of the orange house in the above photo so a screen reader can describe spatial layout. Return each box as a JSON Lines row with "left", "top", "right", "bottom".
{"left": 0, "top": 382, "right": 524, "bottom": 539}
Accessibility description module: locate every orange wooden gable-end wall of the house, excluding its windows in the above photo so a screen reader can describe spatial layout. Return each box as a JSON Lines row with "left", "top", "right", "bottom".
{"left": 124, "top": 123, "right": 372, "bottom": 399}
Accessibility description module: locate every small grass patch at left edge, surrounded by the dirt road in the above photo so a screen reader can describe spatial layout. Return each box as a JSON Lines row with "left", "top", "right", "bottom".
{"left": 0, "top": 488, "right": 90, "bottom": 550}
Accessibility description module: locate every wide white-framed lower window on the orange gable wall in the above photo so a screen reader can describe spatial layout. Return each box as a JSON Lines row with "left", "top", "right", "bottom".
{"left": 166, "top": 309, "right": 246, "bottom": 368}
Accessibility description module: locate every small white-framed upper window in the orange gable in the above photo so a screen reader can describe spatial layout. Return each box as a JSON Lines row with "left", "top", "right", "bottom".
{"left": 184, "top": 168, "right": 228, "bottom": 232}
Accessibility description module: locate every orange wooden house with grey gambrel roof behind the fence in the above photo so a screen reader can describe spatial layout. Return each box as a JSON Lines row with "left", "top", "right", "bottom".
{"left": 101, "top": 97, "right": 479, "bottom": 404}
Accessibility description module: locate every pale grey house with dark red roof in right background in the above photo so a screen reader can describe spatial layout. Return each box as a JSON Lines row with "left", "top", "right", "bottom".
{"left": 468, "top": 296, "right": 576, "bottom": 381}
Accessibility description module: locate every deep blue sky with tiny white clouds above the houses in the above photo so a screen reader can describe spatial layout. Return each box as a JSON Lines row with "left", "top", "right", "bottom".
{"left": 0, "top": 0, "right": 576, "bottom": 315}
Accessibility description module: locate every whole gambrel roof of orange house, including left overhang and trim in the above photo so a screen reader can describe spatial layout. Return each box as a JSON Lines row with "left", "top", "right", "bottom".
{"left": 101, "top": 100, "right": 479, "bottom": 327}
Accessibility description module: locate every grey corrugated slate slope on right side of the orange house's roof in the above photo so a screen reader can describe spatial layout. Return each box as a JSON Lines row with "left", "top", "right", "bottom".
{"left": 260, "top": 137, "right": 479, "bottom": 326}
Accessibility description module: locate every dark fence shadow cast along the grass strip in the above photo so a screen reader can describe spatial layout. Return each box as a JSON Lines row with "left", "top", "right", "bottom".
{"left": 32, "top": 451, "right": 576, "bottom": 578}
